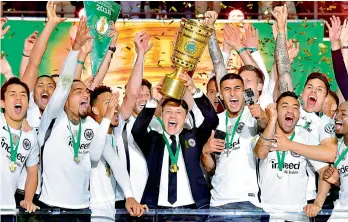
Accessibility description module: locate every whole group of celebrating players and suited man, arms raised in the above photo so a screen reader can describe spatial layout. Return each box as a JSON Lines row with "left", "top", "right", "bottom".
{"left": 0, "top": 2, "right": 348, "bottom": 221}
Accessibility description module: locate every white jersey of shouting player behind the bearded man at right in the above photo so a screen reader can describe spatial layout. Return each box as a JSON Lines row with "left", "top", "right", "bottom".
{"left": 297, "top": 107, "right": 336, "bottom": 200}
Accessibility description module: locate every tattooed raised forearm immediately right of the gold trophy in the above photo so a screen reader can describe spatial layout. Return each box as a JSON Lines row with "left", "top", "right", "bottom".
{"left": 208, "top": 32, "right": 227, "bottom": 92}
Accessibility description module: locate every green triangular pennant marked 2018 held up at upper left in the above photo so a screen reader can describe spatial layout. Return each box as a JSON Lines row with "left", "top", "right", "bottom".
{"left": 83, "top": 1, "right": 121, "bottom": 77}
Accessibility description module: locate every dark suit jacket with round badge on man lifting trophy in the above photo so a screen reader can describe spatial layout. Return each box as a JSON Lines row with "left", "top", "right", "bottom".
{"left": 132, "top": 95, "right": 219, "bottom": 208}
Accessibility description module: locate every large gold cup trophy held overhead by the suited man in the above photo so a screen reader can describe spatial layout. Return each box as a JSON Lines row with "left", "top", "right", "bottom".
{"left": 162, "top": 18, "right": 214, "bottom": 99}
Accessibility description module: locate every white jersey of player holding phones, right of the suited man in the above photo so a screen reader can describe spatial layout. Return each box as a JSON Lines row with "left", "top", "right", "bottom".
{"left": 210, "top": 107, "right": 259, "bottom": 206}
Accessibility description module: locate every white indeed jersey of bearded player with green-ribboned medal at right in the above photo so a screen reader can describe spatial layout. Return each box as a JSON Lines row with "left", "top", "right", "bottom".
{"left": 252, "top": 127, "right": 327, "bottom": 212}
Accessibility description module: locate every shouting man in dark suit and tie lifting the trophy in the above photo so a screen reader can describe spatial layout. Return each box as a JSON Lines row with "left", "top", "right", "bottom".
{"left": 132, "top": 74, "right": 218, "bottom": 209}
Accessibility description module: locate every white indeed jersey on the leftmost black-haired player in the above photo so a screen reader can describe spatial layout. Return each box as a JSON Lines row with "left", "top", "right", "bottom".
{"left": 0, "top": 113, "right": 39, "bottom": 209}
